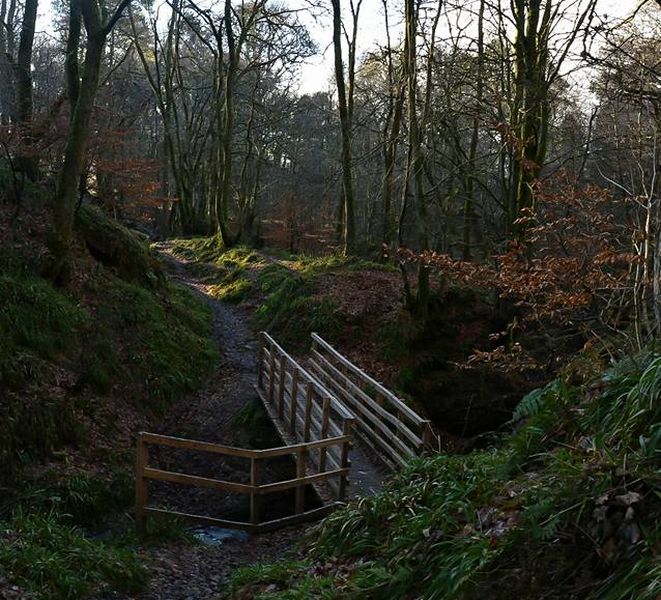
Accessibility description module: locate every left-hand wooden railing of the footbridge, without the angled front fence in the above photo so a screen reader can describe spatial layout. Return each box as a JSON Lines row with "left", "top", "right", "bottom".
{"left": 257, "top": 332, "right": 356, "bottom": 499}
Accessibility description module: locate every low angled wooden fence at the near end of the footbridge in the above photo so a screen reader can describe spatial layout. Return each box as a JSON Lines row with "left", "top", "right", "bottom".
{"left": 136, "top": 432, "right": 351, "bottom": 534}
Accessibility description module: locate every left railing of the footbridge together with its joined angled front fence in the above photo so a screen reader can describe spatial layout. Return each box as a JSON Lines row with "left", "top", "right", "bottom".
{"left": 136, "top": 332, "right": 356, "bottom": 532}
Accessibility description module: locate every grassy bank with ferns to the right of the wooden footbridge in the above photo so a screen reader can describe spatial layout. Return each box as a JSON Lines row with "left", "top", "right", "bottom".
{"left": 228, "top": 353, "right": 661, "bottom": 600}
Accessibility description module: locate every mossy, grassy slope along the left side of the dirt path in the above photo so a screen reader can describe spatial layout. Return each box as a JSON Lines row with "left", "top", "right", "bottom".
{"left": 0, "top": 219, "right": 217, "bottom": 599}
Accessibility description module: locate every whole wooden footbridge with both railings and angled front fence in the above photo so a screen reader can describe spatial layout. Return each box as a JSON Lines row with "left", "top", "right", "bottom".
{"left": 136, "top": 332, "right": 438, "bottom": 533}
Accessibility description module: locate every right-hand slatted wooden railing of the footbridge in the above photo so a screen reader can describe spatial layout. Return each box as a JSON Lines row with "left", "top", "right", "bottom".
{"left": 309, "top": 333, "right": 438, "bottom": 468}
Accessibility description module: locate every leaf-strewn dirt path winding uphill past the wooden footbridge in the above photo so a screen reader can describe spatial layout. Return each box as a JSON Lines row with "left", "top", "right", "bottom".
{"left": 109, "top": 242, "right": 384, "bottom": 600}
